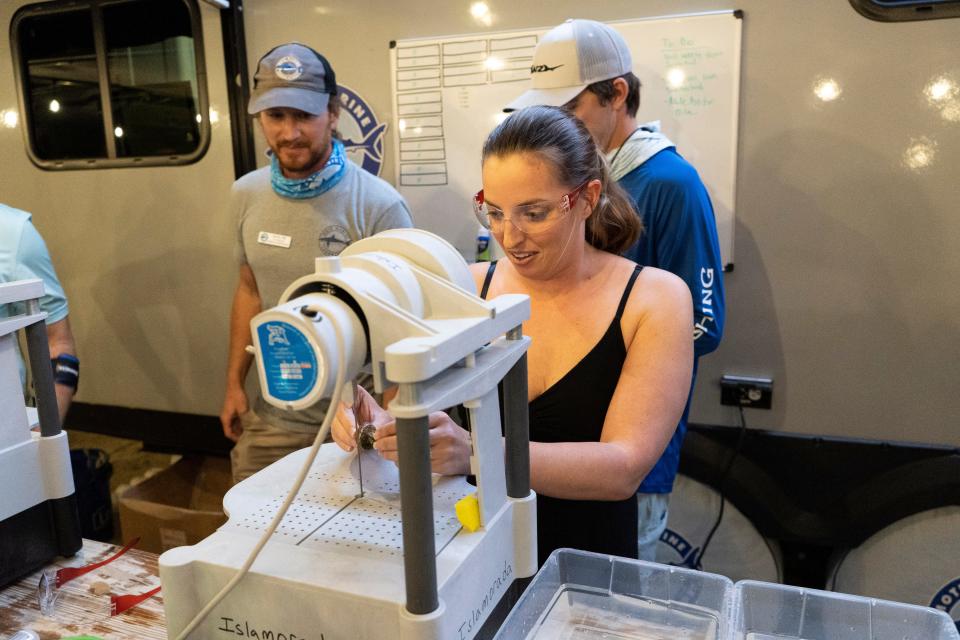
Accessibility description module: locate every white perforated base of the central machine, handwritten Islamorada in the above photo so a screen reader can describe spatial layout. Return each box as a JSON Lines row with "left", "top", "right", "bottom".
{"left": 159, "top": 443, "right": 536, "bottom": 640}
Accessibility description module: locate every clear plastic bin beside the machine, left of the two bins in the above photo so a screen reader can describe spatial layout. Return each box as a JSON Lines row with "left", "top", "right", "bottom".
{"left": 496, "top": 549, "right": 733, "bottom": 640}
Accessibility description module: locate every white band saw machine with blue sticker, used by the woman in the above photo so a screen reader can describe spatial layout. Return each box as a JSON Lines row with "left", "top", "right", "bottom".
{"left": 160, "top": 229, "right": 537, "bottom": 640}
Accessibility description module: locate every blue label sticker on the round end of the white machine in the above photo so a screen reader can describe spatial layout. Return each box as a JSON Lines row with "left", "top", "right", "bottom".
{"left": 257, "top": 322, "right": 318, "bottom": 402}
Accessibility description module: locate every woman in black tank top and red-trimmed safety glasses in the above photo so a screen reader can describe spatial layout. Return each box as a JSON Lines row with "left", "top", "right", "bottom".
{"left": 334, "top": 107, "right": 693, "bottom": 563}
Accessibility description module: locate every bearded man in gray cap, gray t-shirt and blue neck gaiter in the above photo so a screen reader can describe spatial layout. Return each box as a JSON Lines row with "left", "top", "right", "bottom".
{"left": 220, "top": 42, "right": 412, "bottom": 482}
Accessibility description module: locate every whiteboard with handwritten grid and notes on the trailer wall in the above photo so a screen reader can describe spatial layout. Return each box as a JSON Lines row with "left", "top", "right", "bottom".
{"left": 390, "top": 11, "right": 742, "bottom": 268}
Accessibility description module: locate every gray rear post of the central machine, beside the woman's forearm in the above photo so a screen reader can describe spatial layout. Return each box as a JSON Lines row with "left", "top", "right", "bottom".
{"left": 503, "top": 327, "right": 530, "bottom": 498}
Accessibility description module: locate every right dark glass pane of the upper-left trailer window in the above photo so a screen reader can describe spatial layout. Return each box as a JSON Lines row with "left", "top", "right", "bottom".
{"left": 103, "top": 0, "right": 200, "bottom": 158}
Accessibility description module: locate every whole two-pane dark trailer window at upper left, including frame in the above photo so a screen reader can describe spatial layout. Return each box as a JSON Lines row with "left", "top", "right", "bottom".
{"left": 11, "top": 0, "right": 210, "bottom": 169}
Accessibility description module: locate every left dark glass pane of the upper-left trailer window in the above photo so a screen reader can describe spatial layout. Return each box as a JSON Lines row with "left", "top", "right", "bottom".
{"left": 18, "top": 10, "right": 106, "bottom": 160}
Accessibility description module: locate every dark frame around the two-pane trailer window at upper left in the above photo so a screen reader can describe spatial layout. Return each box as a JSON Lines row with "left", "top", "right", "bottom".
{"left": 10, "top": 0, "right": 211, "bottom": 171}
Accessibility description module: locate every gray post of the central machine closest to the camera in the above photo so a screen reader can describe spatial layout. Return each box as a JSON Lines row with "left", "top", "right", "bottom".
{"left": 397, "top": 410, "right": 440, "bottom": 615}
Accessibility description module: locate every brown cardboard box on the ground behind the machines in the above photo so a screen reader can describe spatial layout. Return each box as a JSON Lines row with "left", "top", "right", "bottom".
{"left": 120, "top": 456, "right": 233, "bottom": 553}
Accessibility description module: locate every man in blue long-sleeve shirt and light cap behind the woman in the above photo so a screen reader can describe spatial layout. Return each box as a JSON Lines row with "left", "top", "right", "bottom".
{"left": 505, "top": 20, "right": 724, "bottom": 560}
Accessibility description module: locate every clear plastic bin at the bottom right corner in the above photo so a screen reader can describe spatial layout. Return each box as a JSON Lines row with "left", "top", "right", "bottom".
{"left": 732, "top": 580, "right": 960, "bottom": 640}
